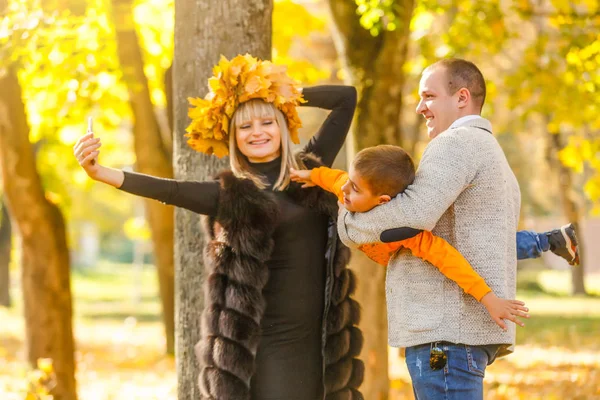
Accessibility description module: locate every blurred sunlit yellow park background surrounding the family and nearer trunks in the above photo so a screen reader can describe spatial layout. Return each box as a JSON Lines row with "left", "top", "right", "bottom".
{"left": 0, "top": 0, "right": 600, "bottom": 400}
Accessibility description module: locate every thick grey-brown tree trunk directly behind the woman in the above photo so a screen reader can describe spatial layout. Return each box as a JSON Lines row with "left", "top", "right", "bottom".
{"left": 173, "top": 0, "right": 273, "bottom": 400}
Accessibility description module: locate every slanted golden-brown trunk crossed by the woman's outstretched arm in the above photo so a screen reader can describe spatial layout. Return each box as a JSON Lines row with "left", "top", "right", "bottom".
{"left": 113, "top": 0, "right": 175, "bottom": 354}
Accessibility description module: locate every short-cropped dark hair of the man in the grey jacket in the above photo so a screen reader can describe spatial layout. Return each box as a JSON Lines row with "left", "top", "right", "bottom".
{"left": 426, "top": 58, "right": 486, "bottom": 111}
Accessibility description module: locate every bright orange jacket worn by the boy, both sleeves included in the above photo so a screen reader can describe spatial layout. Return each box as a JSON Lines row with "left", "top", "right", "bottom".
{"left": 310, "top": 167, "right": 492, "bottom": 301}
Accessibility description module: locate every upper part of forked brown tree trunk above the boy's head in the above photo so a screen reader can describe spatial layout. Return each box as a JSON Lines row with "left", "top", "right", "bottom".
{"left": 329, "top": 0, "right": 414, "bottom": 151}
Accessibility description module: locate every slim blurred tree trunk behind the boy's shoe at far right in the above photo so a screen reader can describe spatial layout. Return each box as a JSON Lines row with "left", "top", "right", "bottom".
{"left": 550, "top": 132, "right": 587, "bottom": 295}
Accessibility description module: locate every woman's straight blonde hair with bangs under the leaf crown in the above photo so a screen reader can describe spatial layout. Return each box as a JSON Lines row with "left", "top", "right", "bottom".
{"left": 229, "top": 99, "right": 304, "bottom": 190}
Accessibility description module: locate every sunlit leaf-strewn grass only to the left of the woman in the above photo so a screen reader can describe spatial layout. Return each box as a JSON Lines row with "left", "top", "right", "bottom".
{"left": 0, "top": 262, "right": 176, "bottom": 400}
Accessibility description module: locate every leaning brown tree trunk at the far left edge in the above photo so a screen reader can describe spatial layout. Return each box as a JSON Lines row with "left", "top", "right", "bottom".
{"left": 0, "top": 68, "right": 77, "bottom": 400}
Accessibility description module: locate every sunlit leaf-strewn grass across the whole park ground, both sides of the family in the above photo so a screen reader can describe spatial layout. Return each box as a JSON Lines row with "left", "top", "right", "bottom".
{"left": 0, "top": 262, "right": 600, "bottom": 400}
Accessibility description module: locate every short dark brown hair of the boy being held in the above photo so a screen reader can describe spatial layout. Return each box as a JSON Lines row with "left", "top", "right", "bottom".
{"left": 352, "top": 144, "right": 415, "bottom": 197}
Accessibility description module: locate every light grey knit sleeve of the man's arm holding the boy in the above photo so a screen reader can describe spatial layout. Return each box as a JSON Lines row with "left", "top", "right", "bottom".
{"left": 338, "top": 128, "right": 479, "bottom": 247}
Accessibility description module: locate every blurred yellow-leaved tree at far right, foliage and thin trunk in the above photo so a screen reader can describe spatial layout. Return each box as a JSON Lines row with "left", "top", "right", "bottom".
{"left": 506, "top": 0, "right": 600, "bottom": 294}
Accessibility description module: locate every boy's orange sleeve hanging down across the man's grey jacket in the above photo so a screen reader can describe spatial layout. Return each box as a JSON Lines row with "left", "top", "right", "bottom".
{"left": 402, "top": 231, "right": 492, "bottom": 301}
